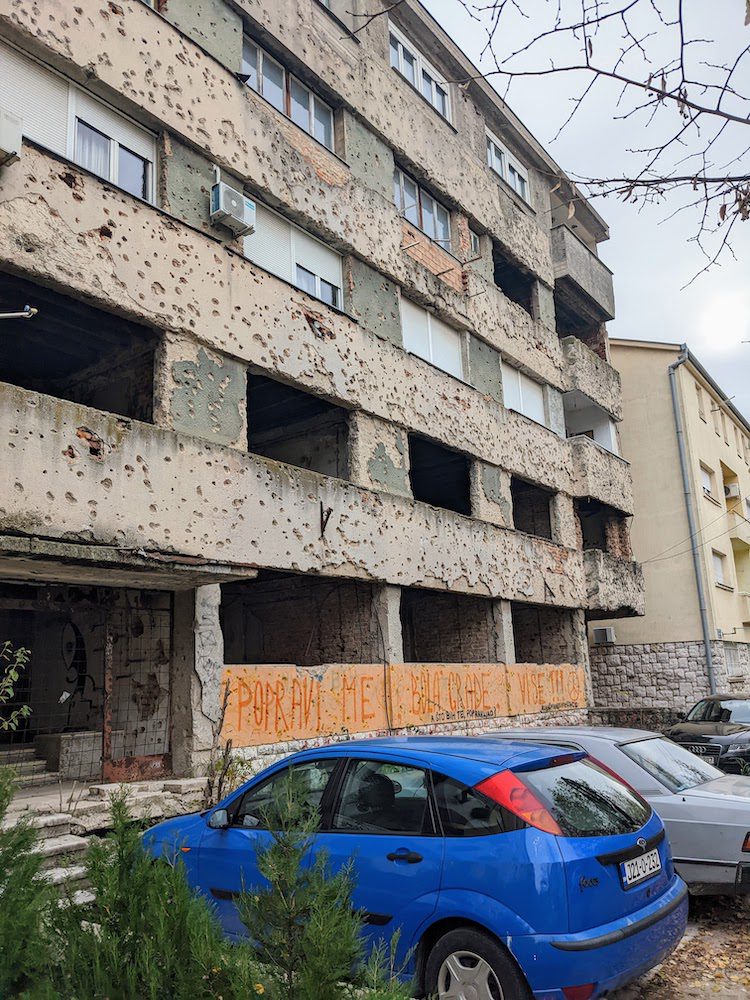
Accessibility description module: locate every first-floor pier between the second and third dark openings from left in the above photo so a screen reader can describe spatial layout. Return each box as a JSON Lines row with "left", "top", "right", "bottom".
{"left": 349, "top": 410, "right": 412, "bottom": 497}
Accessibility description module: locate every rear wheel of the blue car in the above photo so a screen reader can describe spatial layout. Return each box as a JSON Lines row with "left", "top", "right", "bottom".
{"left": 424, "top": 927, "right": 531, "bottom": 1000}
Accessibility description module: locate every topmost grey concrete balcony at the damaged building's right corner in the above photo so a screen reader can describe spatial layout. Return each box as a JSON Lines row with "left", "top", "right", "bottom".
{"left": 552, "top": 226, "right": 615, "bottom": 325}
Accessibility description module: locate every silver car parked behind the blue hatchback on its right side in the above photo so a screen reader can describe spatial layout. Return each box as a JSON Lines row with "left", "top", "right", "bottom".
{"left": 483, "top": 726, "right": 750, "bottom": 895}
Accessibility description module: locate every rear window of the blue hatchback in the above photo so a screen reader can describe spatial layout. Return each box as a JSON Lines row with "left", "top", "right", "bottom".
{"left": 519, "top": 760, "right": 651, "bottom": 837}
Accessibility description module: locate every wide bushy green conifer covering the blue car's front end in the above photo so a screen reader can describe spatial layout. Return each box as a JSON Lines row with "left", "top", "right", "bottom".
{"left": 53, "top": 796, "right": 257, "bottom": 1000}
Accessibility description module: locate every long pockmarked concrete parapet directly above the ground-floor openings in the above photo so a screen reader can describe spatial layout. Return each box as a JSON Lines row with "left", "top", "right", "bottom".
{"left": 0, "top": 383, "right": 585, "bottom": 608}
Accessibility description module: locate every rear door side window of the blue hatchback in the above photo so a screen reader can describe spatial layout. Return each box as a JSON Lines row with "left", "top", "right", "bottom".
{"left": 332, "top": 760, "right": 433, "bottom": 836}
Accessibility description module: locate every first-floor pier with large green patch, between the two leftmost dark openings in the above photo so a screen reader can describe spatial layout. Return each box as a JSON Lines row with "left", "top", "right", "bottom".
{"left": 154, "top": 334, "right": 247, "bottom": 450}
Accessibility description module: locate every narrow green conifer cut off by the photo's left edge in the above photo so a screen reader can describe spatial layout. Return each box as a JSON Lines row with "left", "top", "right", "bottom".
{"left": 0, "top": 772, "right": 53, "bottom": 997}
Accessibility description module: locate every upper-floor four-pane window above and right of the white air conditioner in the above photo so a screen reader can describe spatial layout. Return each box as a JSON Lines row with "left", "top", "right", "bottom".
{"left": 242, "top": 35, "right": 333, "bottom": 149}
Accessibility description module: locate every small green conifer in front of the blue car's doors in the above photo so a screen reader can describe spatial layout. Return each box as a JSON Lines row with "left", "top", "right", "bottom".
{"left": 238, "top": 772, "right": 411, "bottom": 1000}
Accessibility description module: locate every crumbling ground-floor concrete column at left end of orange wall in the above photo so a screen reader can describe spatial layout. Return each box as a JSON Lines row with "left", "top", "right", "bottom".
{"left": 171, "top": 584, "right": 224, "bottom": 777}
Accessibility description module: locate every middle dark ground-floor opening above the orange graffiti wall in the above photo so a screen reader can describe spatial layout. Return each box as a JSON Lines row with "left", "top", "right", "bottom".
{"left": 401, "top": 588, "right": 500, "bottom": 663}
